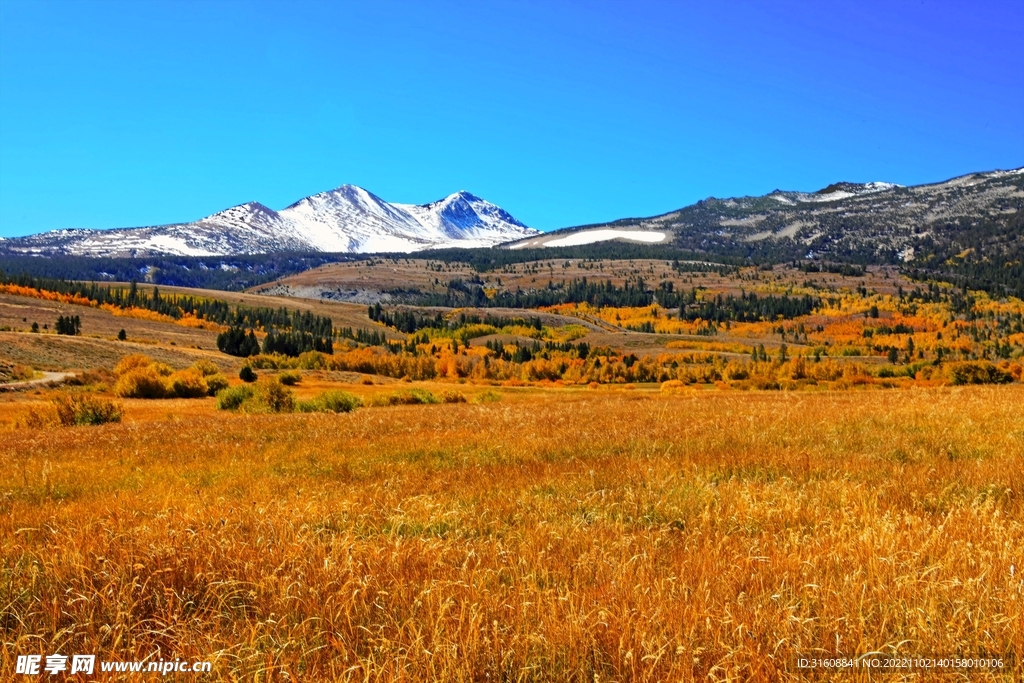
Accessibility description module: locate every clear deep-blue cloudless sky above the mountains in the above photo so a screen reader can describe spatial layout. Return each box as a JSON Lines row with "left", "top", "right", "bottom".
{"left": 0, "top": 0, "right": 1024, "bottom": 237}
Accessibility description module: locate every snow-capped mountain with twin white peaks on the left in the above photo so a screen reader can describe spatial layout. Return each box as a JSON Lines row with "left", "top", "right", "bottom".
{"left": 3, "top": 185, "right": 538, "bottom": 256}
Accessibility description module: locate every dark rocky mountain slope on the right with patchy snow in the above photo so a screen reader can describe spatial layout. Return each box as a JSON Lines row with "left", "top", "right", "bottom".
{"left": 506, "top": 169, "right": 1024, "bottom": 265}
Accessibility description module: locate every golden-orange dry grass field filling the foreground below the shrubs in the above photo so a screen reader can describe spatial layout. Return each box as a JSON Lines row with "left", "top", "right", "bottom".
{"left": 0, "top": 381, "right": 1024, "bottom": 682}
